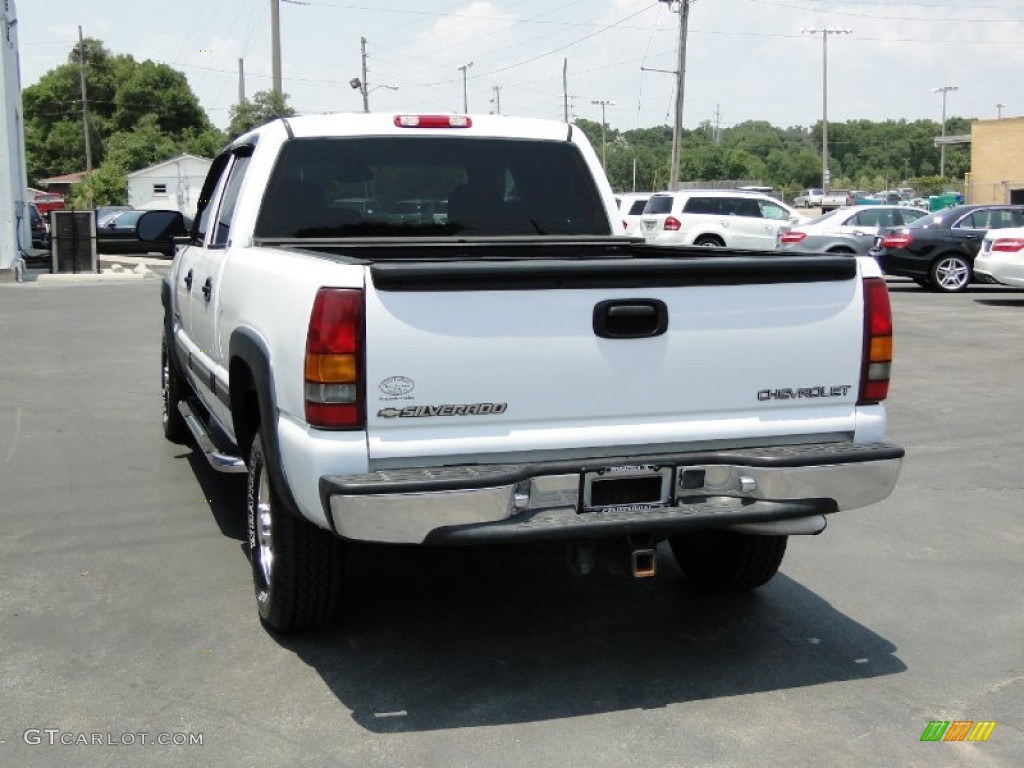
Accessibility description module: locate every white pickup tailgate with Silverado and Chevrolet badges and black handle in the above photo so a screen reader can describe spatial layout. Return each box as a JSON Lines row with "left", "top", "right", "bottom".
{"left": 366, "top": 256, "right": 863, "bottom": 468}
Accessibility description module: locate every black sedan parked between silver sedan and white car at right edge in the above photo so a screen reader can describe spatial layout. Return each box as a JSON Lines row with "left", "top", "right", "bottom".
{"left": 870, "top": 205, "right": 1024, "bottom": 293}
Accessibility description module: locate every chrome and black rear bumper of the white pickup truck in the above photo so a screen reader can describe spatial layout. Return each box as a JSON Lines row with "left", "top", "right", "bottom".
{"left": 321, "top": 443, "right": 904, "bottom": 544}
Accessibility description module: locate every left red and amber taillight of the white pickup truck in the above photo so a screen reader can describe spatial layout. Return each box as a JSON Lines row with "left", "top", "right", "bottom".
{"left": 305, "top": 288, "right": 367, "bottom": 429}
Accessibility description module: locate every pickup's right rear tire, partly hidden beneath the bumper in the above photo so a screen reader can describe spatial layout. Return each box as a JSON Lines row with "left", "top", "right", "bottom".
{"left": 669, "top": 530, "right": 788, "bottom": 592}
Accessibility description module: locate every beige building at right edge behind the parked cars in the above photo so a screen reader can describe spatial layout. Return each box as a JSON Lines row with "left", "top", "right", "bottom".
{"left": 966, "top": 118, "right": 1024, "bottom": 204}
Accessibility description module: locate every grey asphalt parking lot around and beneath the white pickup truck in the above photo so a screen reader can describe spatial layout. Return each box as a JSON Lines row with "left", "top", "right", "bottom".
{"left": 0, "top": 279, "right": 1024, "bottom": 768}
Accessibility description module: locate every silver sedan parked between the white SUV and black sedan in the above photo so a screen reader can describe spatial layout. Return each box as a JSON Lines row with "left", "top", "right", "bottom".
{"left": 775, "top": 205, "right": 928, "bottom": 254}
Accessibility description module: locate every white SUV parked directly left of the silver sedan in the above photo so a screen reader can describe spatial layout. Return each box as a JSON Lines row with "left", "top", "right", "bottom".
{"left": 639, "top": 189, "right": 808, "bottom": 251}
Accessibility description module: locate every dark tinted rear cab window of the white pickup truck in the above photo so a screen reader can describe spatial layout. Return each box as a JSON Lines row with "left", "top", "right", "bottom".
{"left": 255, "top": 136, "right": 612, "bottom": 240}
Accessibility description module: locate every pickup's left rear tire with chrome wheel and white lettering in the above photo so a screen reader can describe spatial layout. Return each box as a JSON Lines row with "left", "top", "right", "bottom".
{"left": 247, "top": 434, "right": 345, "bottom": 632}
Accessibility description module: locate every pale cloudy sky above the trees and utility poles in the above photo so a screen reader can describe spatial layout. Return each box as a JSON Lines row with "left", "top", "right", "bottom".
{"left": 16, "top": 0, "right": 1024, "bottom": 130}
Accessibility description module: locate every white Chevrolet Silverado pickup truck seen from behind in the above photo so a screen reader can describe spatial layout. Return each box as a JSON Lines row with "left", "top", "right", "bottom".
{"left": 138, "top": 115, "right": 903, "bottom": 631}
